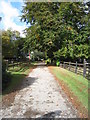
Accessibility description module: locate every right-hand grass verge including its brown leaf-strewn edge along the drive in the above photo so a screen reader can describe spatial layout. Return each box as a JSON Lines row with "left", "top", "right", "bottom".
{"left": 50, "top": 67, "right": 88, "bottom": 117}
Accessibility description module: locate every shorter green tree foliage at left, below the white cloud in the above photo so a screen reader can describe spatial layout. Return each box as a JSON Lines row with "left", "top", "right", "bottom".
{"left": 2, "top": 29, "right": 25, "bottom": 59}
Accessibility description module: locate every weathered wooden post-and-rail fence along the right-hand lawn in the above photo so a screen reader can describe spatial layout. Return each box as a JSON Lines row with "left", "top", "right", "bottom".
{"left": 60, "top": 60, "right": 90, "bottom": 80}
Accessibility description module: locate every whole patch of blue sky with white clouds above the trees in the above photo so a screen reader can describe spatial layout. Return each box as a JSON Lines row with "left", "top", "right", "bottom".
{"left": 0, "top": 0, "right": 27, "bottom": 37}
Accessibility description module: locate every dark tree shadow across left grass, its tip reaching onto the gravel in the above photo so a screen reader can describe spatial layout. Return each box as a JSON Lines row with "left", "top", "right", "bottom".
{"left": 2, "top": 74, "right": 38, "bottom": 95}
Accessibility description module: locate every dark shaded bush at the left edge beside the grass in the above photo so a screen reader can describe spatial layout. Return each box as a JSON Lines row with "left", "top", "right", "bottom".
{"left": 2, "top": 60, "right": 11, "bottom": 90}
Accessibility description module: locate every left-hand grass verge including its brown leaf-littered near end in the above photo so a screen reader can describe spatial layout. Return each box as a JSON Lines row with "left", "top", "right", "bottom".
{"left": 2, "top": 62, "right": 35, "bottom": 108}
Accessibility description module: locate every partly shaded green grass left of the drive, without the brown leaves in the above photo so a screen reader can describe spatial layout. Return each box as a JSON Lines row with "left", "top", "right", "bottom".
{"left": 2, "top": 62, "right": 34, "bottom": 95}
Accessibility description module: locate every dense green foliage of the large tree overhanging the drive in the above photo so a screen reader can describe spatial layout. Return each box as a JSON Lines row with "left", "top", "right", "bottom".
{"left": 21, "top": 2, "right": 90, "bottom": 61}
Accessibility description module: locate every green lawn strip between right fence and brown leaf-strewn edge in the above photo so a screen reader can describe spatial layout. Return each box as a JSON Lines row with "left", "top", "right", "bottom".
{"left": 52, "top": 67, "right": 88, "bottom": 109}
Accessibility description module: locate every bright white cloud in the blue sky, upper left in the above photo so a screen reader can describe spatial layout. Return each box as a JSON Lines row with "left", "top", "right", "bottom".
{"left": 0, "top": 1, "right": 26, "bottom": 37}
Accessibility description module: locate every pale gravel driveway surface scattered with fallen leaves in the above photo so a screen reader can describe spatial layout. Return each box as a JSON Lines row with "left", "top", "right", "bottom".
{"left": 1, "top": 65, "right": 78, "bottom": 118}
